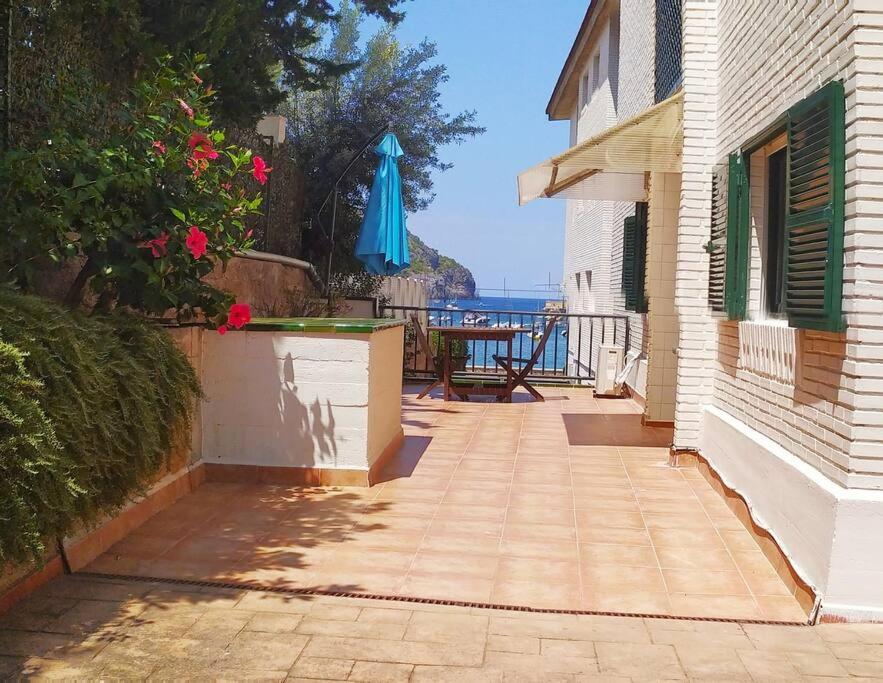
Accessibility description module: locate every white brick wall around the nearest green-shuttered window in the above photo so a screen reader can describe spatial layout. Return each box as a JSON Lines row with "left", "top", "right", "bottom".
{"left": 675, "top": 0, "right": 883, "bottom": 488}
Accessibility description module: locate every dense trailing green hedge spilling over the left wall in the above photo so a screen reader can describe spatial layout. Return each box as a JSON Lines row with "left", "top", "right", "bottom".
{"left": 0, "top": 289, "right": 200, "bottom": 566}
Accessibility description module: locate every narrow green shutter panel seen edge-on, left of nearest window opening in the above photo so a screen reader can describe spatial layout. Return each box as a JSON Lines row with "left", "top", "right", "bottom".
{"left": 724, "top": 154, "right": 751, "bottom": 320}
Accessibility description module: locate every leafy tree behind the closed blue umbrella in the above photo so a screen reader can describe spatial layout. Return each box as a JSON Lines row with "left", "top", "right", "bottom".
{"left": 280, "top": 2, "right": 484, "bottom": 272}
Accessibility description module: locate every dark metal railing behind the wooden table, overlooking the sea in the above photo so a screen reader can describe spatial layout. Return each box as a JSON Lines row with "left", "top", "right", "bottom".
{"left": 381, "top": 305, "right": 630, "bottom": 384}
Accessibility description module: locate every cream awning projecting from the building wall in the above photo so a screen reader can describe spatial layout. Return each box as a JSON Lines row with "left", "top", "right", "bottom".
{"left": 518, "top": 92, "right": 684, "bottom": 204}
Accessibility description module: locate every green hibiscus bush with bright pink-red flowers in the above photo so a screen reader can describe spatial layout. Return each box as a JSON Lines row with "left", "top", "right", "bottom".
{"left": 0, "top": 57, "right": 271, "bottom": 327}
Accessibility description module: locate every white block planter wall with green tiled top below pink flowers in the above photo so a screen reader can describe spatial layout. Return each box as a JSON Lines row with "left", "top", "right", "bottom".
{"left": 200, "top": 326, "right": 404, "bottom": 485}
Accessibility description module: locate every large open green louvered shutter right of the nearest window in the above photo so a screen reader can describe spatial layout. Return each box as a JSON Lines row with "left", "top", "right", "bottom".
{"left": 785, "top": 81, "right": 846, "bottom": 331}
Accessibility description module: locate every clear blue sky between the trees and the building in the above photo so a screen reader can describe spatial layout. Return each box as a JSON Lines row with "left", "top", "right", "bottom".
{"left": 365, "top": 0, "right": 588, "bottom": 296}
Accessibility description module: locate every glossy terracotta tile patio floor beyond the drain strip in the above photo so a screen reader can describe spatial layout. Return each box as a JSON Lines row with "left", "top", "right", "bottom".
{"left": 89, "top": 389, "right": 806, "bottom": 621}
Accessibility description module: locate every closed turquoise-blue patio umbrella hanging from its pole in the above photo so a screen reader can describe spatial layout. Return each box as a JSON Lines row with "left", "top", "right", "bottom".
{"left": 356, "top": 133, "right": 411, "bottom": 275}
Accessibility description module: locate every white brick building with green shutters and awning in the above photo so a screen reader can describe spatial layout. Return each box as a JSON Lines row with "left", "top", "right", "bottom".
{"left": 519, "top": 0, "right": 883, "bottom": 619}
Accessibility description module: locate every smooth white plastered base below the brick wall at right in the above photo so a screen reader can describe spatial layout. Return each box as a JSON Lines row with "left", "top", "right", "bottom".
{"left": 700, "top": 407, "right": 883, "bottom": 621}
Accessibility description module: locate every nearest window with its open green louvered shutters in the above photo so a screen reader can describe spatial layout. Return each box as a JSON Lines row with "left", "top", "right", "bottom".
{"left": 706, "top": 81, "right": 846, "bottom": 331}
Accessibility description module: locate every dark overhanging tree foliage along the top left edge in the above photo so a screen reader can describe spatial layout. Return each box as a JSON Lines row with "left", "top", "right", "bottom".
{"left": 3, "top": 0, "right": 404, "bottom": 140}
